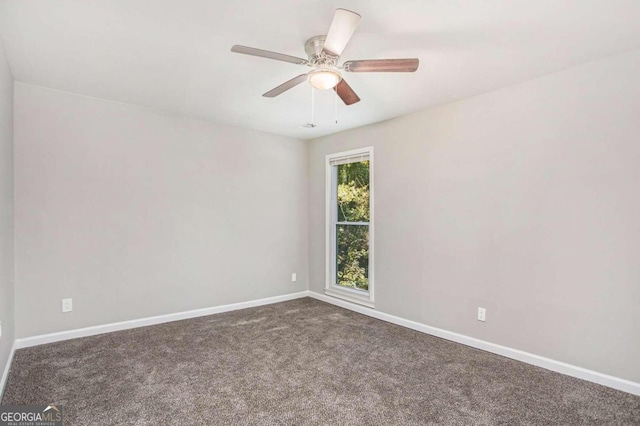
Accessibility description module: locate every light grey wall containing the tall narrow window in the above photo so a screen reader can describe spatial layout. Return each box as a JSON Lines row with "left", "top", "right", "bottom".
{"left": 309, "top": 51, "right": 640, "bottom": 382}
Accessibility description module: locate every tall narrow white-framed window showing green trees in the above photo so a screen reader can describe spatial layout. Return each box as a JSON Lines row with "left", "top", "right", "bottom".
{"left": 325, "top": 147, "right": 374, "bottom": 307}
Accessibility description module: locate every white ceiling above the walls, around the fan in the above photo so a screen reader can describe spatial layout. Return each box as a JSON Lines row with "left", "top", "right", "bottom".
{"left": 0, "top": 0, "right": 640, "bottom": 139}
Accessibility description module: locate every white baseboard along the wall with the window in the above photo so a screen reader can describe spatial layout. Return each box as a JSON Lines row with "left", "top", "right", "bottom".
{"left": 309, "top": 291, "right": 640, "bottom": 396}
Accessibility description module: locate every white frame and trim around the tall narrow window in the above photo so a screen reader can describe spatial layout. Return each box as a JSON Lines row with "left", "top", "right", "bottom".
{"left": 324, "top": 146, "right": 375, "bottom": 308}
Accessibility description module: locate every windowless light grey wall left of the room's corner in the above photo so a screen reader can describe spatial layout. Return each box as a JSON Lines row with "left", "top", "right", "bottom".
{"left": 15, "top": 83, "right": 308, "bottom": 337}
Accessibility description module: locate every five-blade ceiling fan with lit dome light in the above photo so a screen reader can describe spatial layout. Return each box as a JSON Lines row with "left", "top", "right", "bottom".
{"left": 231, "top": 9, "right": 419, "bottom": 105}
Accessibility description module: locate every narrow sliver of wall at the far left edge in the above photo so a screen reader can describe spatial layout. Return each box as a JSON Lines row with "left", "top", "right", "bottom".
{"left": 0, "top": 35, "right": 15, "bottom": 384}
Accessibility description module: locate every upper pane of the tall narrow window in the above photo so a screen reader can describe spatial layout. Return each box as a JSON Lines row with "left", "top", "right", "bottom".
{"left": 336, "top": 161, "right": 369, "bottom": 222}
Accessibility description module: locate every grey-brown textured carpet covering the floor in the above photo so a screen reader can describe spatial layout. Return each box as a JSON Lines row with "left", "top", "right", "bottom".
{"left": 2, "top": 298, "right": 640, "bottom": 425}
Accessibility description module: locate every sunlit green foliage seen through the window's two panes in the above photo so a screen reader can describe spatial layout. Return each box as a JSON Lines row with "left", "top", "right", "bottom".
{"left": 336, "top": 161, "right": 370, "bottom": 290}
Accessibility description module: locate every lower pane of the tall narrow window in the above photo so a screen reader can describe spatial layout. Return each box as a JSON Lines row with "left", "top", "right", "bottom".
{"left": 336, "top": 225, "right": 369, "bottom": 290}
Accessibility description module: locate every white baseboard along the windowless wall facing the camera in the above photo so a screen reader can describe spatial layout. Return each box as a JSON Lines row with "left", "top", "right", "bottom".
{"left": 16, "top": 291, "right": 309, "bottom": 352}
